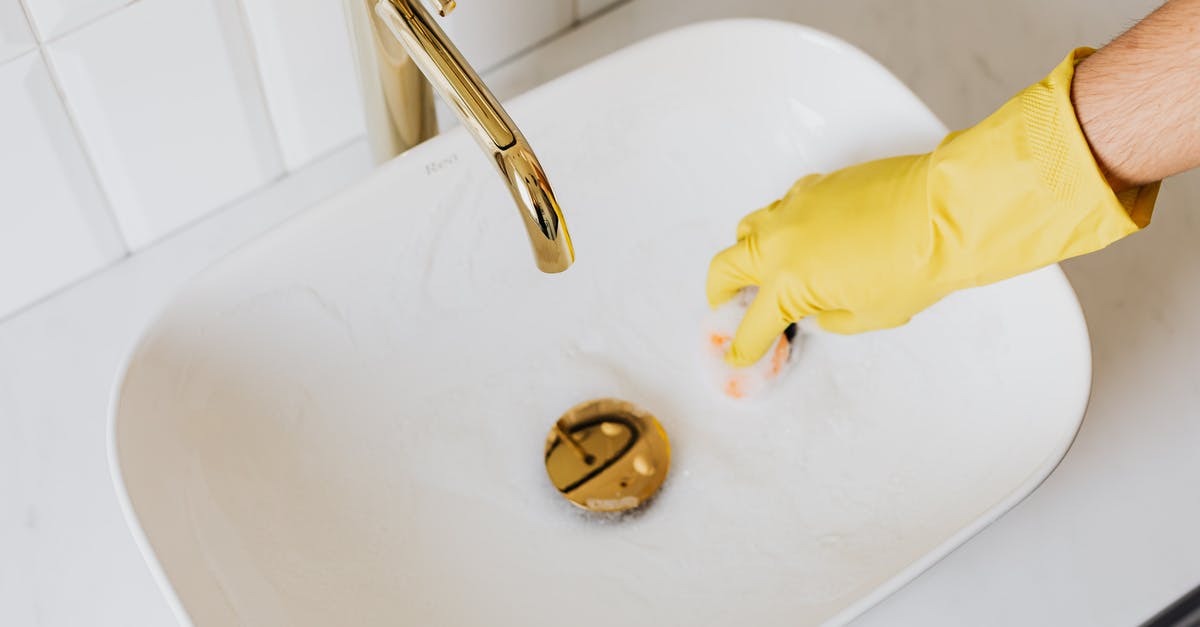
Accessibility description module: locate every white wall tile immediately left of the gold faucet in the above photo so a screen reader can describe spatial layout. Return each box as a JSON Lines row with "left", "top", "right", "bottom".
{"left": 242, "top": 0, "right": 365, "bottom": 169}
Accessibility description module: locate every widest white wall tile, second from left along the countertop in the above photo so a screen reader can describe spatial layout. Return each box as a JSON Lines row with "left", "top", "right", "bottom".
{"left": 48, "top": 0, "right": 282, "bottom": 249}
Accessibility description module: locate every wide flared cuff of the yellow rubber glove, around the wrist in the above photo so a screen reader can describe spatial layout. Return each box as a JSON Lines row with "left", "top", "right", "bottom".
{"left": 926, "top": 48, "right": 1159, "bottom": 288}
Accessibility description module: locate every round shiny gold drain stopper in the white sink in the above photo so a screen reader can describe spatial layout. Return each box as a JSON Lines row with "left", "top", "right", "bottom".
{"left": 546, "top": 399, "right": 671, "bottom": 512}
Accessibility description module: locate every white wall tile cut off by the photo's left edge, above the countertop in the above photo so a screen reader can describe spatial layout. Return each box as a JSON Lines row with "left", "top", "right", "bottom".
{"left": 0, "top": 52, "right": 125, "bottom": 317}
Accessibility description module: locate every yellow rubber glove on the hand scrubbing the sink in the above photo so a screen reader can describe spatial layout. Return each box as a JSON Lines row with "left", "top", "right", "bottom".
{"left": 708, "top": 48, "right": 1158, "bottom": 365}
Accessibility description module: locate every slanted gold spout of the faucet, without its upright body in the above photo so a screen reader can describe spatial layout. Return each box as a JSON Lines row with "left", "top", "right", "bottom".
{"left": 368, "top": 0, "right": 575, "bottom": 273}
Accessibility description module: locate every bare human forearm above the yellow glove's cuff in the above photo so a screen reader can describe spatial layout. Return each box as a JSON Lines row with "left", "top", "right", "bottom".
{"left": 1072, "top": 0, "right": 1200, "bottom": 191}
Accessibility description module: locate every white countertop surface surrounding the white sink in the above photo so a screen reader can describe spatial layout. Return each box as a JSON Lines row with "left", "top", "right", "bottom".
{"left": 0, "top": 0, "right": 1200, "bottom": 626}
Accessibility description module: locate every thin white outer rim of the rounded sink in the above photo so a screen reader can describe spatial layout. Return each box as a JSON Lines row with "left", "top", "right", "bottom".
{"left": 106, "top": 19, "right": 1093, "bottom": 625}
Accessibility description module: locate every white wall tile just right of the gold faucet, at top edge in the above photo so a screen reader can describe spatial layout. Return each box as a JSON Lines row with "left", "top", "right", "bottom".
{"left": 442, "top": 0, "right": 575, "bottom": 71}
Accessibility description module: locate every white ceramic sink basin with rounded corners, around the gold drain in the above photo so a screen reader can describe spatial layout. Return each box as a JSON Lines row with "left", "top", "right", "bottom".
{"left": 112, "top": 20, "right": 1091, "bottom": 626}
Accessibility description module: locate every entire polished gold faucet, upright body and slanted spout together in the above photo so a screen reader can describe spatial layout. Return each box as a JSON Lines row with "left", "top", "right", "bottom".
{"left": 346, "top": 0, "right": 575, "bottom": 273}
